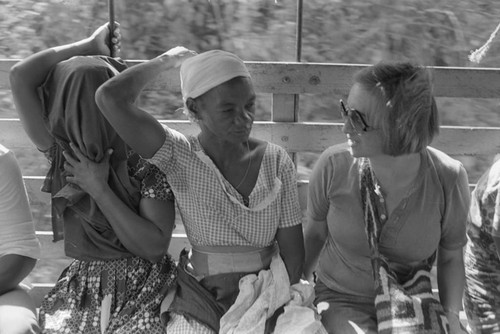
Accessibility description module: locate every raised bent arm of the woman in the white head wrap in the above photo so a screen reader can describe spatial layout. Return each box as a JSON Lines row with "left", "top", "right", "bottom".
{"left": 96, "top": 47, "right": 195, "bottom": 158}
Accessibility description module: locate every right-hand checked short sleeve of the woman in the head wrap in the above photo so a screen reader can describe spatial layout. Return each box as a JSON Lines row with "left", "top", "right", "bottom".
{"left": 278, "top": 152, "right": 302, "bottom": 228}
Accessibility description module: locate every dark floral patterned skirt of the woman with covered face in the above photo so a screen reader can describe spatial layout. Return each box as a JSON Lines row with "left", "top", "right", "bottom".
{"left": 39, "top": 255, "right": 176, "bottom": 334}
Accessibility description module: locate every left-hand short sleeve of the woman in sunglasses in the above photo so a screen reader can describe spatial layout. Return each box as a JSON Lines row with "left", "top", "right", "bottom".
{"left": 307, "top": 150, "right": 334, "bottom": 221}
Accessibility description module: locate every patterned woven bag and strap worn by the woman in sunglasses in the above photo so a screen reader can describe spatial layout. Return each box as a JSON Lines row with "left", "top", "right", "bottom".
{"left": 359, "top": 159, "right": 449, "bottom": 334}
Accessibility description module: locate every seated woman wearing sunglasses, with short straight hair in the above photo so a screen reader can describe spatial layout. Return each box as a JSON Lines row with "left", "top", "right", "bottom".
{"left": 304, "top": 62, "right": 469, "bottom": 334}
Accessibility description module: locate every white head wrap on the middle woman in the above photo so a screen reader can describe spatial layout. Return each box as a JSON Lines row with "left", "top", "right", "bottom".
{"left": 180, "top": 50, "right": 250, "bottom": 102}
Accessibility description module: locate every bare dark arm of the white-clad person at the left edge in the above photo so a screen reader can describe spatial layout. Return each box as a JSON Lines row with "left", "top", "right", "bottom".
{"left": 0, "top": 254, "right": 36, "bottom": 295}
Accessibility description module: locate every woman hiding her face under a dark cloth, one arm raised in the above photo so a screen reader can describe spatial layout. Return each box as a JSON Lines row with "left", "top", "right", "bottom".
{"left": 10, "top": 24, "right": 176, "bottom": 333}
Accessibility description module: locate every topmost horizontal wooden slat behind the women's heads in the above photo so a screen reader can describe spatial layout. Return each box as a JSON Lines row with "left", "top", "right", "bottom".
{"left": 0, "top": 59, "right": 500, "bottom": 98}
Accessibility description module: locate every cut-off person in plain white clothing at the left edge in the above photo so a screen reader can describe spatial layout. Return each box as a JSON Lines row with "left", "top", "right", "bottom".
{"left": 0, "top": 145, "right": 40, "bottom": 334}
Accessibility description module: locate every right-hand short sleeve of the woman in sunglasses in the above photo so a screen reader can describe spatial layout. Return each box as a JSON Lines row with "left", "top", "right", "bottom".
{"left": 440, "top": 164, "right": 470, "bottom": 250}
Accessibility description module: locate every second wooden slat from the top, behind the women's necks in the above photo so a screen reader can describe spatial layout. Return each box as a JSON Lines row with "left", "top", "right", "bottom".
{"left": 0, "top": 119, "right": 500, "bottom": 156}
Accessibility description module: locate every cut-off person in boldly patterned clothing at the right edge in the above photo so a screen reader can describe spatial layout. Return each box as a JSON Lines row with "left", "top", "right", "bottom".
{"left": 464, "top": 156, "right": 500, "bottom": 334}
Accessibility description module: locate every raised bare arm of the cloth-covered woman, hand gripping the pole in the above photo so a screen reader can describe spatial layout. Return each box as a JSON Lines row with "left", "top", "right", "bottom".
{"left": 9, "top": 23, "right": 120, "bottom": 151}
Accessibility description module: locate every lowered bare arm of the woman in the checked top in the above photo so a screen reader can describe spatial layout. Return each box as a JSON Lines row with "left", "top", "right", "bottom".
{"left": 276, "top": 225, "right": 304, "bottom": 284}
